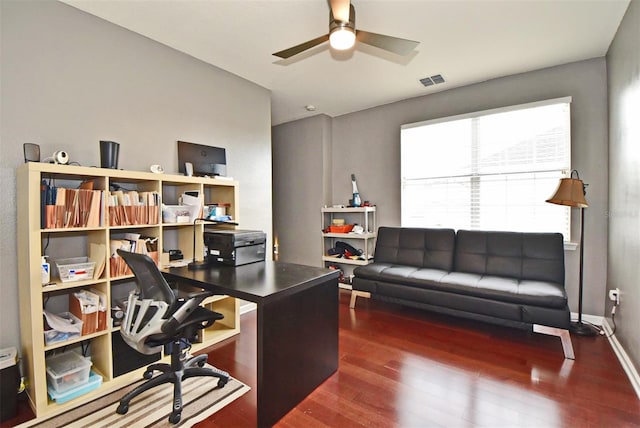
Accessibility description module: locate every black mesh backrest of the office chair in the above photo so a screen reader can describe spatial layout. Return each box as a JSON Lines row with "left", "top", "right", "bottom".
{"left": 117, "top": 250, "right": 179, "bottom": 354}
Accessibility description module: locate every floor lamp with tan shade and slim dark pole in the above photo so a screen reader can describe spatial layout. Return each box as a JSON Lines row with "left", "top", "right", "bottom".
{"left": 547, "top": 169, "right": 599, "bottom": 336}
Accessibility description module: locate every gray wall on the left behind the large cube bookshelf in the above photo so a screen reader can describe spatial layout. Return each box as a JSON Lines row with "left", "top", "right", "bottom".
{"left": 0, "top": 0, "right": 272, "bottom": 347}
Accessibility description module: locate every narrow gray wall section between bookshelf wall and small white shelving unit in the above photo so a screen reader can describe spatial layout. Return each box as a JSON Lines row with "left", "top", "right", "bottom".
{"left": 272, "top": 115, "right": 331, "bottom": 266}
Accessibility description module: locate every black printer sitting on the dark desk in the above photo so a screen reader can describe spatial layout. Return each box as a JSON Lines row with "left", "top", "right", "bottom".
{"left": 204, "top": 229, "right": 267, "bottom": 266}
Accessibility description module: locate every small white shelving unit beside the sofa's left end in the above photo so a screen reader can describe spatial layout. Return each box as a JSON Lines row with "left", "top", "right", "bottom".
{"left": 321, "top": 207, "right": 377, "bottom": 289}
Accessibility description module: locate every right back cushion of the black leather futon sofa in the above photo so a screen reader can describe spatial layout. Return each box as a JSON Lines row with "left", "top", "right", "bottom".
{"left": 454, "top": 230, "right": 564, "bottom": 284}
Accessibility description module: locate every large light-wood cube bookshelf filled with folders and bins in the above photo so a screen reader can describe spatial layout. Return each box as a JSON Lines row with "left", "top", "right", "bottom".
{"left": 17, "top": 163, "right": 240, "bottom": 417}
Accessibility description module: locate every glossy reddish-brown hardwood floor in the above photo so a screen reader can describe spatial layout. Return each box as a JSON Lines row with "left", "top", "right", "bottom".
{"left": 2, "top": 290, "right": 640, "bottom": 428}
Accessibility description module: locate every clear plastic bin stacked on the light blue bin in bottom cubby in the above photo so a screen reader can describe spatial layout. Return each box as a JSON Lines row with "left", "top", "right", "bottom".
{"left": 47, "top": 352, "right": 91, "bottom": 392}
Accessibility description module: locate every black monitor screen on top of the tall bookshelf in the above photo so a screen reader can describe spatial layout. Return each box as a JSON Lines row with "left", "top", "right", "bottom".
{"left": 178, "top": 141, "right": 227, "bottom": 177}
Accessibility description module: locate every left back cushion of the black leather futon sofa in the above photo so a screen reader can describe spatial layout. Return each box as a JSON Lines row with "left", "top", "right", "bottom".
{"left": 375, "top": 227, "right": 456, "bottom": 271}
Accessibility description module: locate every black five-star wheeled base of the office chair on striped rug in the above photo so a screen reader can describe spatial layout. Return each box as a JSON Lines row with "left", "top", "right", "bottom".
{"left": 116, "top": 339, "right": 229, "bottom": 424}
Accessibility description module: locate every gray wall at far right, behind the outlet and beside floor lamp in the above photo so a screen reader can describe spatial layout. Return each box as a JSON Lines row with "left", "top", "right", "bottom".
{"left": 607, "top": 0, "right": 640, "bottom": 368}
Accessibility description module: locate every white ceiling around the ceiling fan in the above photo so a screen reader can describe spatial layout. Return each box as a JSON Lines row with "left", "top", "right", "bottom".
{"left": 62, "top": 0, "right": 629, "bottom": 125}
